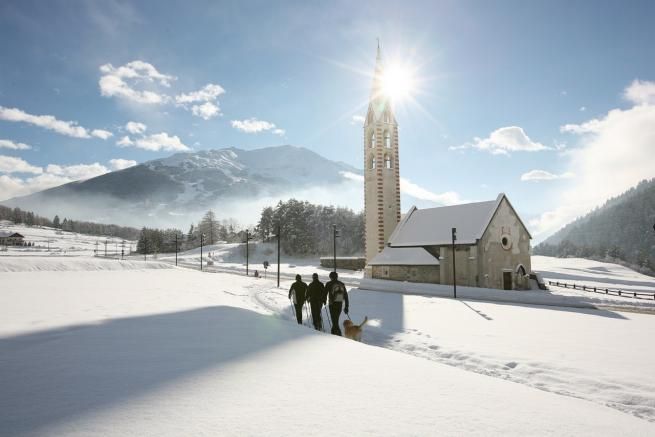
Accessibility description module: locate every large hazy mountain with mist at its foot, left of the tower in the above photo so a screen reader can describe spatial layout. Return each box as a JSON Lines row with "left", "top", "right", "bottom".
{"left": 2, "top": 145, "right": 362, "bottom": 225}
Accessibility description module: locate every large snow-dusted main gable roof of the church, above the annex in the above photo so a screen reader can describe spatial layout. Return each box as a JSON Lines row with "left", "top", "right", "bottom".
{"left": 389, "top": 193, "right": 529, "bottom": 248}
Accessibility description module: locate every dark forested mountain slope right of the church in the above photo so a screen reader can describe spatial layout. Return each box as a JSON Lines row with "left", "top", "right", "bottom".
{"left": 534, "top": 179, "right": 655, "bottom": 272}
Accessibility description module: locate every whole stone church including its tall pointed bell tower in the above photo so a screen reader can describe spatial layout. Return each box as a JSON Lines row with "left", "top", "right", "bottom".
{"left": 364, "top": 44, "right": 532, "bottom": 290}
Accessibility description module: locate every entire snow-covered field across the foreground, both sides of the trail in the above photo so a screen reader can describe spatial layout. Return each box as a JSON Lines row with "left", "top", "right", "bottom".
{"left": 0, "top": 230, "right": 655, "bottom": 436}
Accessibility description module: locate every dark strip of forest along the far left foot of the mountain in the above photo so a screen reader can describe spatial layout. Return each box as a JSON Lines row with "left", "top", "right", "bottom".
{"left": 0, "top": 205, "right": 139, "bottom": 240}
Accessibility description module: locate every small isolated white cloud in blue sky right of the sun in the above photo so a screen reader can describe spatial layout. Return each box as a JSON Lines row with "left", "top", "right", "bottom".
{"left": 450, "top": 126, "right": 551, "bottom": 155}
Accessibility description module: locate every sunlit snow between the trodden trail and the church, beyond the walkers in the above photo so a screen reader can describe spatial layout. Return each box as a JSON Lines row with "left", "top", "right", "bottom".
{"left": 252, "top": 280, "right": 655, "bottom": 422}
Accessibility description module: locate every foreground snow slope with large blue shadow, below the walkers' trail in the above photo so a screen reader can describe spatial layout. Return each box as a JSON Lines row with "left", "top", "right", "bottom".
{"left": 0, "top": 269, "right": 655, "bottom": 436}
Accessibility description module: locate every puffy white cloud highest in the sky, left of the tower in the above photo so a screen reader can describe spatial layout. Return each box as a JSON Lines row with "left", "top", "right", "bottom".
{"left": 98, "top": 60, "right": 176, "bottom": 104}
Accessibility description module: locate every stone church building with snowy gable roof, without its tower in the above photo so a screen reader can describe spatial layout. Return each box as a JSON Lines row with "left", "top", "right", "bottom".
{"left": 369, "top": 193, "right": 532, "bottom": 289}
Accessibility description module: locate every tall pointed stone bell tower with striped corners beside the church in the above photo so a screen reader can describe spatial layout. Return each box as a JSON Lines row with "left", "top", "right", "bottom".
{"left": 364, "top": 42, "right": 400, "bottom": 262}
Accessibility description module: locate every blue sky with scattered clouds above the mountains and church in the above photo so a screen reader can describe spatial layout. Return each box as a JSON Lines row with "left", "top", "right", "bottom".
{"left": 0, "top": 1, "right": 655, "bottom": 238}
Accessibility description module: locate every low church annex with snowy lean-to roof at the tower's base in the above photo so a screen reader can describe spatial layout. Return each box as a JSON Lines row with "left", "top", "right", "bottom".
{"left": 369, "top": 247, "right": 441, "bottom": 284}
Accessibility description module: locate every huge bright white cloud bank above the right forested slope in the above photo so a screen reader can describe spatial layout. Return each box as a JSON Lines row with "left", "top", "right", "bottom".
{"left": 530, "top": 82, "right": 655, "bottom": 237}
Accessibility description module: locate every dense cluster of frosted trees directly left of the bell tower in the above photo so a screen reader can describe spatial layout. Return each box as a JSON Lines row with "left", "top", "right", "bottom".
{"left": 256, "top": 199, "right": 364, "bottom": 256}
